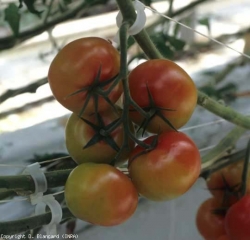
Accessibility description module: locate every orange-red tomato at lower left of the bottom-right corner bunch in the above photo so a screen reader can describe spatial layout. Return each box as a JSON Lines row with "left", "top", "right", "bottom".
{"left": 196, "top": 198, "right": 226, "bottom": 240}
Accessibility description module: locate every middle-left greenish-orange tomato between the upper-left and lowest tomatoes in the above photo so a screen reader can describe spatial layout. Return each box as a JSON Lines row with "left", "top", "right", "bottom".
{"left": 65, "top": 109, "right": 135, "bottom": 164}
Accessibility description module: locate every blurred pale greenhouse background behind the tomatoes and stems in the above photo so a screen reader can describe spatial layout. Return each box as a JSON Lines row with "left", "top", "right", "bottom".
{"left": 0, "top": 0, "right": 250, "bottom": 240}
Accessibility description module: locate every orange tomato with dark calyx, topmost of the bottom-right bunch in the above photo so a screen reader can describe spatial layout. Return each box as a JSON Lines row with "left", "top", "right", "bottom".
{"left": 207, "top": 161, "right": 250, "bottom": 205}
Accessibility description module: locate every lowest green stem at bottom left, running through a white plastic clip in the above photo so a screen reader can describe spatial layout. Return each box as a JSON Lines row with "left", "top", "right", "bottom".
{"left": 0, "top": 207, "right": 74, "bottom": 235}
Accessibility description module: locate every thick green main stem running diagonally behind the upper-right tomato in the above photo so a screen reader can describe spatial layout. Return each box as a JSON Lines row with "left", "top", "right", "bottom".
{"left": 116, "top": 0, "right": 250, "bottom": 129}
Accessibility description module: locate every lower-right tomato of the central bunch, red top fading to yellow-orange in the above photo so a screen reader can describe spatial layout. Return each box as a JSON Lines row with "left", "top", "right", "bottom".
{"left": 128, "top": 131, "right": 201, "bottom": 201}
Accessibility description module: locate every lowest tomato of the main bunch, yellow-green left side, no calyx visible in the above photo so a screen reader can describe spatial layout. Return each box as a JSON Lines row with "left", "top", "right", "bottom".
{"left": 65, "top": 163, "right": 138, "bottom": 226}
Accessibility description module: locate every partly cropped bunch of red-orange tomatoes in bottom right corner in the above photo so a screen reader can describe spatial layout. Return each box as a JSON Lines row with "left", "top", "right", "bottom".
{"left": 196, "top": 161, "right": 250, "bottom": 240}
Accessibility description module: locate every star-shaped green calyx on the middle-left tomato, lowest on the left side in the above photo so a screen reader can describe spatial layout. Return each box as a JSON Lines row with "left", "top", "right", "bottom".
{"left": 81, "top": 113, "right": 120, "bottom": 152}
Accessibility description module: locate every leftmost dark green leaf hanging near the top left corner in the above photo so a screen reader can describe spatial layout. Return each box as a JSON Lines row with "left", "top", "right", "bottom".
{"left": 4, "top": 3, "right": 20, "bottom": 36}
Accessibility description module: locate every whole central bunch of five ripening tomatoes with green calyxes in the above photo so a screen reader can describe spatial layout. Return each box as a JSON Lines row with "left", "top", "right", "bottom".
{"left": 48, "top": 37, "right": 201, "bottom": 226}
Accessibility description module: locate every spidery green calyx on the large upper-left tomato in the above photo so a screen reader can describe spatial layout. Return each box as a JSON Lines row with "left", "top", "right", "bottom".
{"left": 65, "top": 64, "right": 118, "bottom": 117}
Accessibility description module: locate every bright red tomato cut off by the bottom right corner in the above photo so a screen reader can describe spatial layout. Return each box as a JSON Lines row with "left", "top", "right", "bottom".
{"left": 225, "top": 195, "right": 250, "bottom": 240}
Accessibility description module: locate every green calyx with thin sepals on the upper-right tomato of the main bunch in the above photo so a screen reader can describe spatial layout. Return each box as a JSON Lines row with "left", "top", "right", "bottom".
{"left": 130, "top": 83, "right": 177, "bottom": 136}
